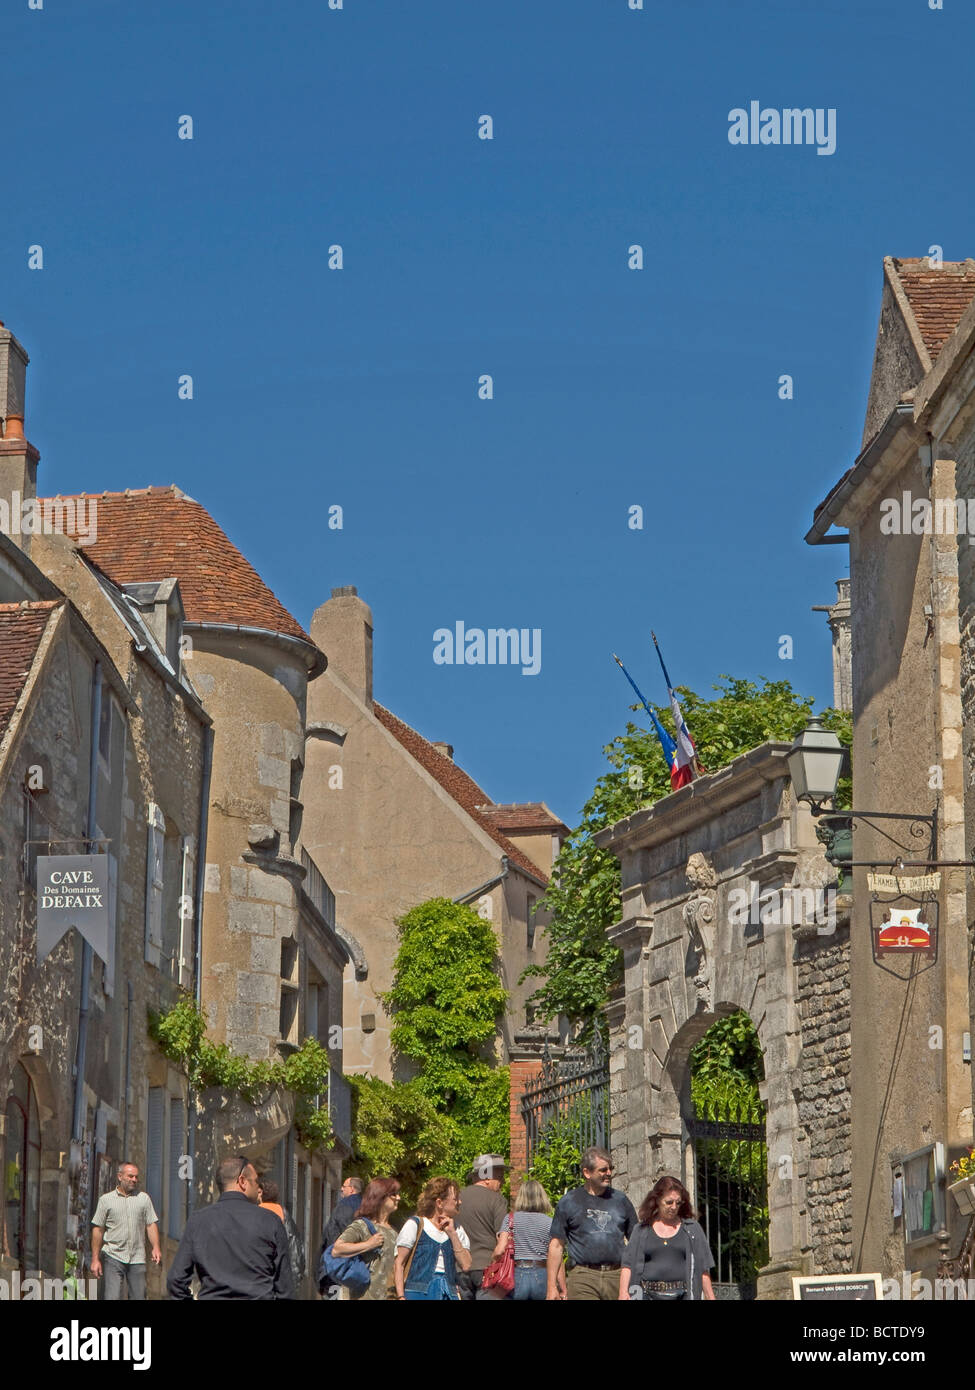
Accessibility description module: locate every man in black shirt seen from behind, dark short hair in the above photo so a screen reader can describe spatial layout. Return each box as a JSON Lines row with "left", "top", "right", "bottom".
{"left": 166, "top": 1155, "right": 293, "bottom": 1301}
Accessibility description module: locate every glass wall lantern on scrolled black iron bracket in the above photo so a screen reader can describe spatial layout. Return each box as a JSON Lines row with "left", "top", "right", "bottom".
{"left": 787, "top": 719, "right": 934, "bottom": 869}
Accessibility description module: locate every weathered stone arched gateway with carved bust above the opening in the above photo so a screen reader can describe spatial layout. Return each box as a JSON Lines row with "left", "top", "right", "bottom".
{"left": 595, "top": 744, "right": 851, "bottom": 1298}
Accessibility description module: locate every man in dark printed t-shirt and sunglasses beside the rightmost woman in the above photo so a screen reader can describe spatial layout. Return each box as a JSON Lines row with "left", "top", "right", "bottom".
{"left": 545, "top": 1148, "right": 637, "bottom": 1302}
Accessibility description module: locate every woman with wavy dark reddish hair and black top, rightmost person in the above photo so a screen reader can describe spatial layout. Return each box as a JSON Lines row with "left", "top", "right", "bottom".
{"left": 619, "top": 1177, "right": 715, "bottom": 1302}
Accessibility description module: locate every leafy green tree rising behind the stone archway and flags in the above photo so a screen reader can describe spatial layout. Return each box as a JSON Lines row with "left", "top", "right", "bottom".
{"left": 522, "top": 676, "right": 851, "bottom": 1037}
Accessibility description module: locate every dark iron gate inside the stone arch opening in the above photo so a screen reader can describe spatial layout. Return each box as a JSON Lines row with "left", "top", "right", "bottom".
{"left": 684, "top": 1104, "right": 769, "bottom": 1298}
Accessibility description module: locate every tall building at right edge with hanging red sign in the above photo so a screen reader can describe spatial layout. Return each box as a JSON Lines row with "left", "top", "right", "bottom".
{"left": 807, "top": 257, "right": 975, "bottom": 1279}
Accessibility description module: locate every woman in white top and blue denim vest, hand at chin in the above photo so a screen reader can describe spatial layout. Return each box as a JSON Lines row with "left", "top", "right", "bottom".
{"left": 394, "top": 1177, "right": 470, "bottom": 1302}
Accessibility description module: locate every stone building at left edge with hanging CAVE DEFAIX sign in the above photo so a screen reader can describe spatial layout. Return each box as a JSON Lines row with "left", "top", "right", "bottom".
{"left": 0, "top": 329, "right": 210, "bottom": 1279}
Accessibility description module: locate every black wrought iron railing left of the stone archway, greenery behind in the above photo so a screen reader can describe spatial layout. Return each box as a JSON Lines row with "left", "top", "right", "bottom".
{"left": 522, "top": 1036, "right": 609, "bottom": 1166}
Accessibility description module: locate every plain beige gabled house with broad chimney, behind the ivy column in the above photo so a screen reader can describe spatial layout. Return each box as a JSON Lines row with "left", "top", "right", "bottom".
{"left": 303, "top": 588, "right": 567, "bottom": 1080}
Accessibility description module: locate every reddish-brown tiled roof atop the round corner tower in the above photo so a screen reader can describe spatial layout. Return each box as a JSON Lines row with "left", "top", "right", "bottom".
{"left": 38, "top": 487, "right": 312, "bottom": 642}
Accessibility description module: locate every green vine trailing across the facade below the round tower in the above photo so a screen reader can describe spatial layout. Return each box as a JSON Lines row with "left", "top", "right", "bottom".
{"left": 149, "top": 994, "right": 332, "bottom": 1151}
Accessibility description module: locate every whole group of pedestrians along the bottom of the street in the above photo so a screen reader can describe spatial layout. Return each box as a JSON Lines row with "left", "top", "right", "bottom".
{"left": 85, "top": 1148, "right": 715, "bottom": 1302}
